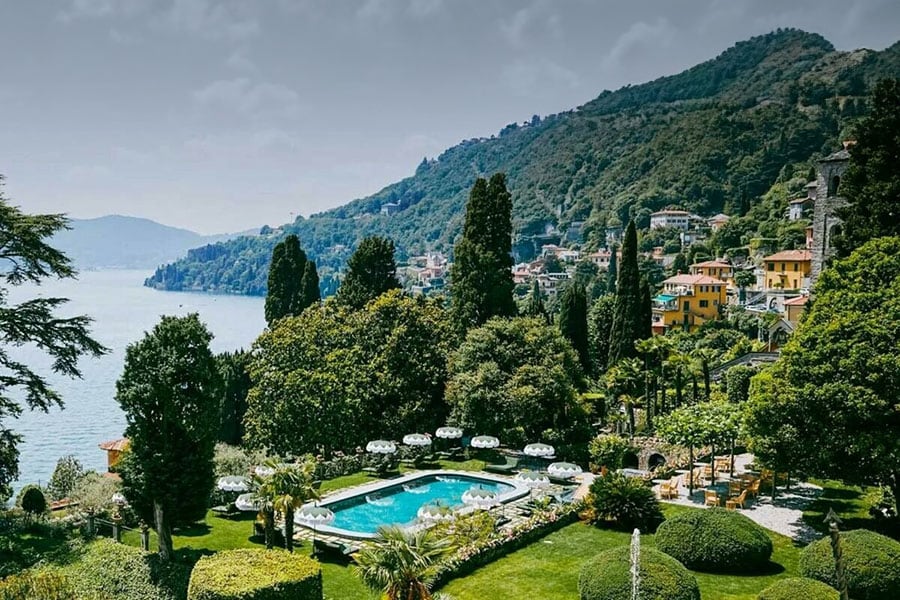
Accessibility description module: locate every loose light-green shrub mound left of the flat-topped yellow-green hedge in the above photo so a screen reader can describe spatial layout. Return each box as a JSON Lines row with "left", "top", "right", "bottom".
{"left": 60, "top": 539, "right": 187, "bottom": 600}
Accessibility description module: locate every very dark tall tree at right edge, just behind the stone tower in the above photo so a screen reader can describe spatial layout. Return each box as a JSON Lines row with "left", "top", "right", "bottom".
{"left": 835, "top": 79, "right": 900, "bottom": 256}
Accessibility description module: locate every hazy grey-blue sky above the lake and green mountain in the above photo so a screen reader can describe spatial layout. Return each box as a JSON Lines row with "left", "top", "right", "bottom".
{"left": 0, "top": 0, "right": 900, "bottom": 233}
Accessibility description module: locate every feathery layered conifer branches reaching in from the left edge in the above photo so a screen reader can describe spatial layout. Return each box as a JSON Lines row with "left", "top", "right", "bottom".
{"left": 0, "top": 175, "right": 108, "bottom": 503}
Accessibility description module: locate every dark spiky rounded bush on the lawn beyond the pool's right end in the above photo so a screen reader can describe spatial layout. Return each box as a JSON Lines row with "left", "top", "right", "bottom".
{"left": 588, "top": 473, "right": 663, "bottom": 531}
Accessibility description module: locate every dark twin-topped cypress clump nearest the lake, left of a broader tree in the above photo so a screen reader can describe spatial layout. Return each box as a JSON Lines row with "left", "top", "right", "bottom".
{"left": 265, "top": 234, "right": 318, "bottom": 327}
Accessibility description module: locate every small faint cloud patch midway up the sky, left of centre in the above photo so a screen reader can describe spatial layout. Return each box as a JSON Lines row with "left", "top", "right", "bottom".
{"left": 191, "top": 77, "right": 301, "bottom": 120}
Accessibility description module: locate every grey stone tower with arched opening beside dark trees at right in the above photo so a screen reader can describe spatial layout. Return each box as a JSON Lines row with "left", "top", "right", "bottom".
{"left": 809, "top": 147, "right": 850, "bottom": 286}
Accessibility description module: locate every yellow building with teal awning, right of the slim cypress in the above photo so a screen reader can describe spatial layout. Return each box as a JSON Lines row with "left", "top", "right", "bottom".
{"left": 653, "top": 275, "right": 727, "bottom": 333}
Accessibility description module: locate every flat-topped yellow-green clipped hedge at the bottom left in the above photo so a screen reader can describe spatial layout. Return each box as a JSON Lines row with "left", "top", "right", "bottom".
{"left": 187, "top": 549, "right": 322, "bottom": 600}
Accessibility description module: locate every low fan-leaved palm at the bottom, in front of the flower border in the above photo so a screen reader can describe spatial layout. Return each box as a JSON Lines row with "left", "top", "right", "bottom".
{"left": 354, "top": 526, "right": 451, "bottom": 600}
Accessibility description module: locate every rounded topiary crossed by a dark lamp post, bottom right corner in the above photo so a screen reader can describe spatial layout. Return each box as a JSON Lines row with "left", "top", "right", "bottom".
{"left": 800, "top": 529, "right": 900, "bottom": 600}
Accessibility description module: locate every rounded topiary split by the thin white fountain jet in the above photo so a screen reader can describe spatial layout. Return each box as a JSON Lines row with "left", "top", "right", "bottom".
{"left": 578, "top": 546, "right": 700, "bottom": 600}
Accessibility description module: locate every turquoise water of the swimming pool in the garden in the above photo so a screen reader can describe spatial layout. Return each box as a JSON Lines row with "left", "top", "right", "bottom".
{"left": 328, "top": 475, "right": 514, "bottom": 534}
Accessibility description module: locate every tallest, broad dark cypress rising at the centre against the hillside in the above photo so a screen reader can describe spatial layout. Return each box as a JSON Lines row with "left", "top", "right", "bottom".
{"left": 450, "top": 173, "right": 516, "bottom": 332}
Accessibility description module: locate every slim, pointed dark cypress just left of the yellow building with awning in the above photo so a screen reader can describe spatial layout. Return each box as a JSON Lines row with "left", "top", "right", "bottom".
{"left": 609, "top": 220, "right": 644, "bottom": 366}
